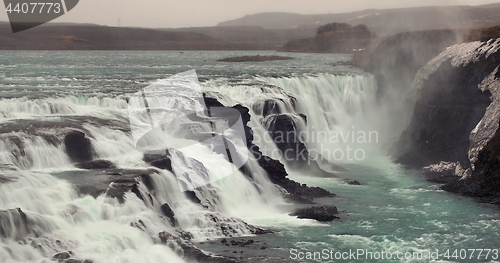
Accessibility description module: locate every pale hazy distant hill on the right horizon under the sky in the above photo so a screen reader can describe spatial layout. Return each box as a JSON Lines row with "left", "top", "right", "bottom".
{"left": 217, "top": 3, "right": 500, "bottom": 36}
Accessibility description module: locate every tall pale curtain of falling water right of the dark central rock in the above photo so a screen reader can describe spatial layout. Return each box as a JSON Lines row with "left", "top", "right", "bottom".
{"left": 262, "top": 74, "right": 379, "bottom": 163}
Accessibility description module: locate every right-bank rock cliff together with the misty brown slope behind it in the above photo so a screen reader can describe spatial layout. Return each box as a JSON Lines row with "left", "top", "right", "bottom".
{"left": 354, "top": 26, "right": 500, "bottom": 204}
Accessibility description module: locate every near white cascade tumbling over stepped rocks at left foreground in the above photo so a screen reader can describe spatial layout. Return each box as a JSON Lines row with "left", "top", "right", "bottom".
{"left": 0, "top": 71, "right": 286, "bottom": 262}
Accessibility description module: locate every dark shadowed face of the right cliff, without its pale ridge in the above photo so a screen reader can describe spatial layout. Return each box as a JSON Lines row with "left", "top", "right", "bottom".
{"left": 396, "top": 56, "right": 494, "bottom": 168}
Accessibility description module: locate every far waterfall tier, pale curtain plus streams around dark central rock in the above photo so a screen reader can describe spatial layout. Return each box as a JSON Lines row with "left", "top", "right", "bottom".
{"left": 205, "top": 74, "right": 386, "bottom": 170}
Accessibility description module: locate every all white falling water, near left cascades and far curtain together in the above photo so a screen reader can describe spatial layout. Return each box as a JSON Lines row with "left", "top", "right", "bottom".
{"left": 0, "top": 69, "right": 387, "bottom": 262}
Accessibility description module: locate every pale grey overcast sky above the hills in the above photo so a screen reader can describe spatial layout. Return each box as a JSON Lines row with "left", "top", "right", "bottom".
{"left": 0, "top": 0, "right": 500, "bottom": 27}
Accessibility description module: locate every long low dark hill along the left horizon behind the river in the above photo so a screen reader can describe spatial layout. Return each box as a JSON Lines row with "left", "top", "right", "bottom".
{"left": 0, "top": 22, "right": 316, "bottom": 50}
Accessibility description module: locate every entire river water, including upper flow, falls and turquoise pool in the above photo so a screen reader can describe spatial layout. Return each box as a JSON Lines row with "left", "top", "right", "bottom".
{"left": 0, "top": 51, "right": 500, "bottom": 263}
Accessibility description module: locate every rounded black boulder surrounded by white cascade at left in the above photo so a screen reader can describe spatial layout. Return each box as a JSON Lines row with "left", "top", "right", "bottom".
{"left": 64, "top": 131, "right": 93, "bottom": 162}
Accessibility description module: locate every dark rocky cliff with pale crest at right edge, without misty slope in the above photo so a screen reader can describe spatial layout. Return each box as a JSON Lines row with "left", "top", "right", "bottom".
{"left": 396, "top": 39, "right": 500, "bottom": 203}
